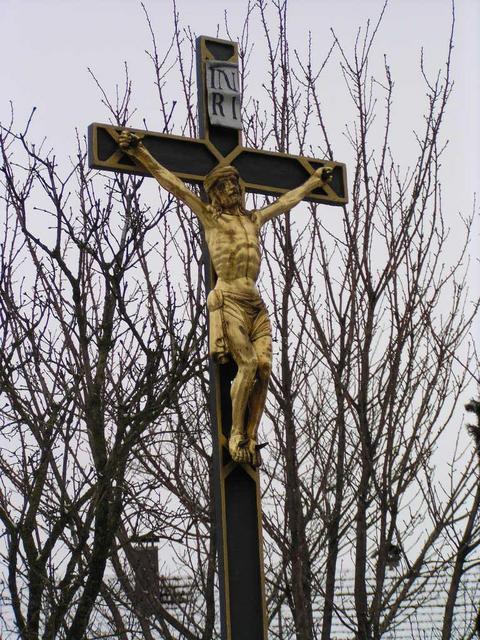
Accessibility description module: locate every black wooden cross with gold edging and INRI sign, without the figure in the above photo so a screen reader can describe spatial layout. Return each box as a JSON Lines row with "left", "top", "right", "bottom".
{"left": 88, "top": 36, "right": 347, "bottom": 640}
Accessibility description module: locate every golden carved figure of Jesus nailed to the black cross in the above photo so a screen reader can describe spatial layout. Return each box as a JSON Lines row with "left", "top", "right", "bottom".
{"left": 119, "top": 131, "right": 332, "bottom": 467}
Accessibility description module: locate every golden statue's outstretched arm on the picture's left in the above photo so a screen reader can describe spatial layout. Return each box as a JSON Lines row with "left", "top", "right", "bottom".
{"left": 118, "top": 131, "right": 208, "bottom": 226}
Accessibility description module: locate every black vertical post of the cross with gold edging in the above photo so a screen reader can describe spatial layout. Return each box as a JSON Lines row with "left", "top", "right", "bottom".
{"left": 197, "top": 36, "right": 268, "bottom": 640}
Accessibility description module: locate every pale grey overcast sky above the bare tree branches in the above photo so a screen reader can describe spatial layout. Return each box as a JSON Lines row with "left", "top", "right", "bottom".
{"left": 0, "top": 0, "right": 480, "bottom": 340}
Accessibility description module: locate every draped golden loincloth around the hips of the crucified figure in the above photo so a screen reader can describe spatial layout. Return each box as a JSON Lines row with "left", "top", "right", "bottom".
{"left": 207, "top": 288, "right": 272, "bottom": 363}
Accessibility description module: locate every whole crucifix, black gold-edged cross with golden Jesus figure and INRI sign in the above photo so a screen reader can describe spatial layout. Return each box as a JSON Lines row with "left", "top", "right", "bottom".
{"left": 89, "top": 36, "right": 347, "bottom": 640}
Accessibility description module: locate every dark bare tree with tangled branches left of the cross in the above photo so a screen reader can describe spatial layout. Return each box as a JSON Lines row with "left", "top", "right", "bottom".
{"left": 0, "top": 70, "right": 208, "bottom": 640}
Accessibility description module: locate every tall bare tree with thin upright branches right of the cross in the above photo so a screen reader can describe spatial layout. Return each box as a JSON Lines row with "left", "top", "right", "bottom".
{"left": 248, "top": 2, "right": 479, "bottom": 640}
